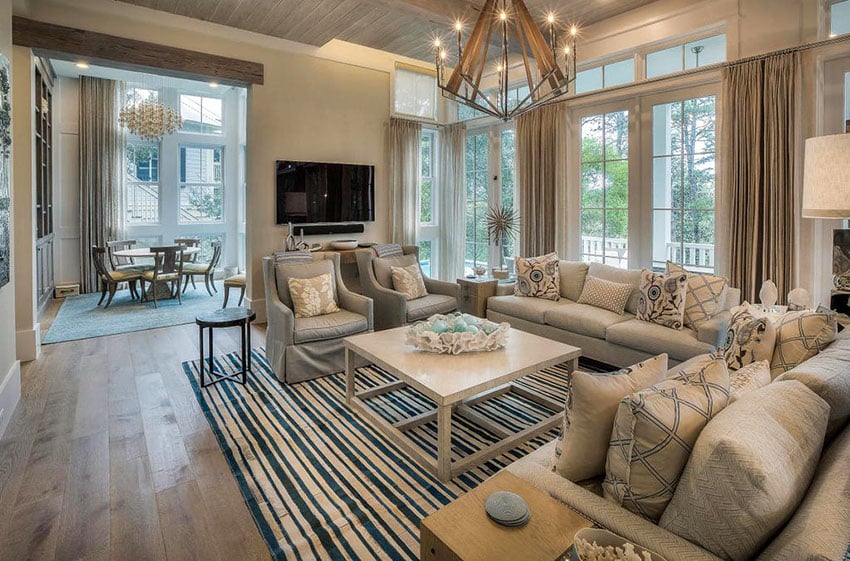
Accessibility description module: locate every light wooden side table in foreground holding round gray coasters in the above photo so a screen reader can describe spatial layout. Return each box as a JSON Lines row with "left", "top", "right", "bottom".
{"left": 419, "top": 471, "right": 593, "bottom": 561}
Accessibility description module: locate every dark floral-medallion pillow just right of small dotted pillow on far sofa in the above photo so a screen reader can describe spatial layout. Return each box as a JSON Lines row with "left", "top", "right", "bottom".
{"left": 637, "top": 269, "right": 688, "bottom": 329}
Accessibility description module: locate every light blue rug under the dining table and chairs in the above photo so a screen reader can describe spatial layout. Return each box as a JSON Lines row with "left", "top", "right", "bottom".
{"left": 42, "top": 281, "right": 229, "bottom": 343}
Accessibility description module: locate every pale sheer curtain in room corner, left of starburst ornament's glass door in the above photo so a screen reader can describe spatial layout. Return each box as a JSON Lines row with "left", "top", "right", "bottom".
{"left": 437, "top": 123, "right": 466, "bottom": 281}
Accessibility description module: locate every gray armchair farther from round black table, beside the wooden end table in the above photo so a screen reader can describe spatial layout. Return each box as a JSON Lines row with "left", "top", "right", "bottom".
{"left": 356, "top": 245, "right": 460, "bottom": 330}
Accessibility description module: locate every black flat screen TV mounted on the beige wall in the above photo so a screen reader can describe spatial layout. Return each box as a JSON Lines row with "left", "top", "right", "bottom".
{"left": 275, "top": 160, "right": 375, "bottom": 224}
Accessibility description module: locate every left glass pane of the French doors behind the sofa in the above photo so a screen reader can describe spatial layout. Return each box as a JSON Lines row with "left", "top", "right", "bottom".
{"left": 581, "top": 111, "right": 629, "bottom": 268}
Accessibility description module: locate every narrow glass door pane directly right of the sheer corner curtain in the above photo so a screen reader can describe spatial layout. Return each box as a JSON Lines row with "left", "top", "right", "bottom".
{"left": 464, "top": 133, "right": 489, "bottom": 273}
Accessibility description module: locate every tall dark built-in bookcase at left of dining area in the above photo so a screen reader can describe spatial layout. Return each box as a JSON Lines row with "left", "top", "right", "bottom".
{"left": 33, "top": 59, "right": 55, "bottom": 310}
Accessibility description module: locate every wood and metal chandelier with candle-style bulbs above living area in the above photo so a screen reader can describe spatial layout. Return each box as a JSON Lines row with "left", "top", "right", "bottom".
{"left": 434, "top": 0, "right": 578, "bottom": 121}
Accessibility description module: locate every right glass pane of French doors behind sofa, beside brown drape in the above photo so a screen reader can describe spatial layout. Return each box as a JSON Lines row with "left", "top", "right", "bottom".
{"left": 652, "top": 96, "right": 715, "bottom": 272}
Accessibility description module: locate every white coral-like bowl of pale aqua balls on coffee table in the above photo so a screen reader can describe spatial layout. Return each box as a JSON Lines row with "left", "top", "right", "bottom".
{"left": 405, "top": 312, "right": 510, "bottom": 355}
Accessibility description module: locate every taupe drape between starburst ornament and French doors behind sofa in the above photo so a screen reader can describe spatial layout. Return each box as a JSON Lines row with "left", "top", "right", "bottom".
{"left": 516, "top": 104, "right": 567, "bottom": 257}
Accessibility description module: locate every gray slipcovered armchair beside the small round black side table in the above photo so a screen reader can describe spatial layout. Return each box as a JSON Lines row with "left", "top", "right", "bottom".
{"left": 263, "top": 252, "right": 373, "bottom": 383}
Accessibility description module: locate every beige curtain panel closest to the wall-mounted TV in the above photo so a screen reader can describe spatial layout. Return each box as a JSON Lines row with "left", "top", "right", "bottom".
{"left": 389, "top": 118, "right": 422, "bottom": 245}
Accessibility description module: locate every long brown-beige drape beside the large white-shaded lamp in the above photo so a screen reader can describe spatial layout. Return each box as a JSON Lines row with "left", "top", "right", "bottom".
{"left": 721, "top": 53, "right": 800, "bottom": 302}
